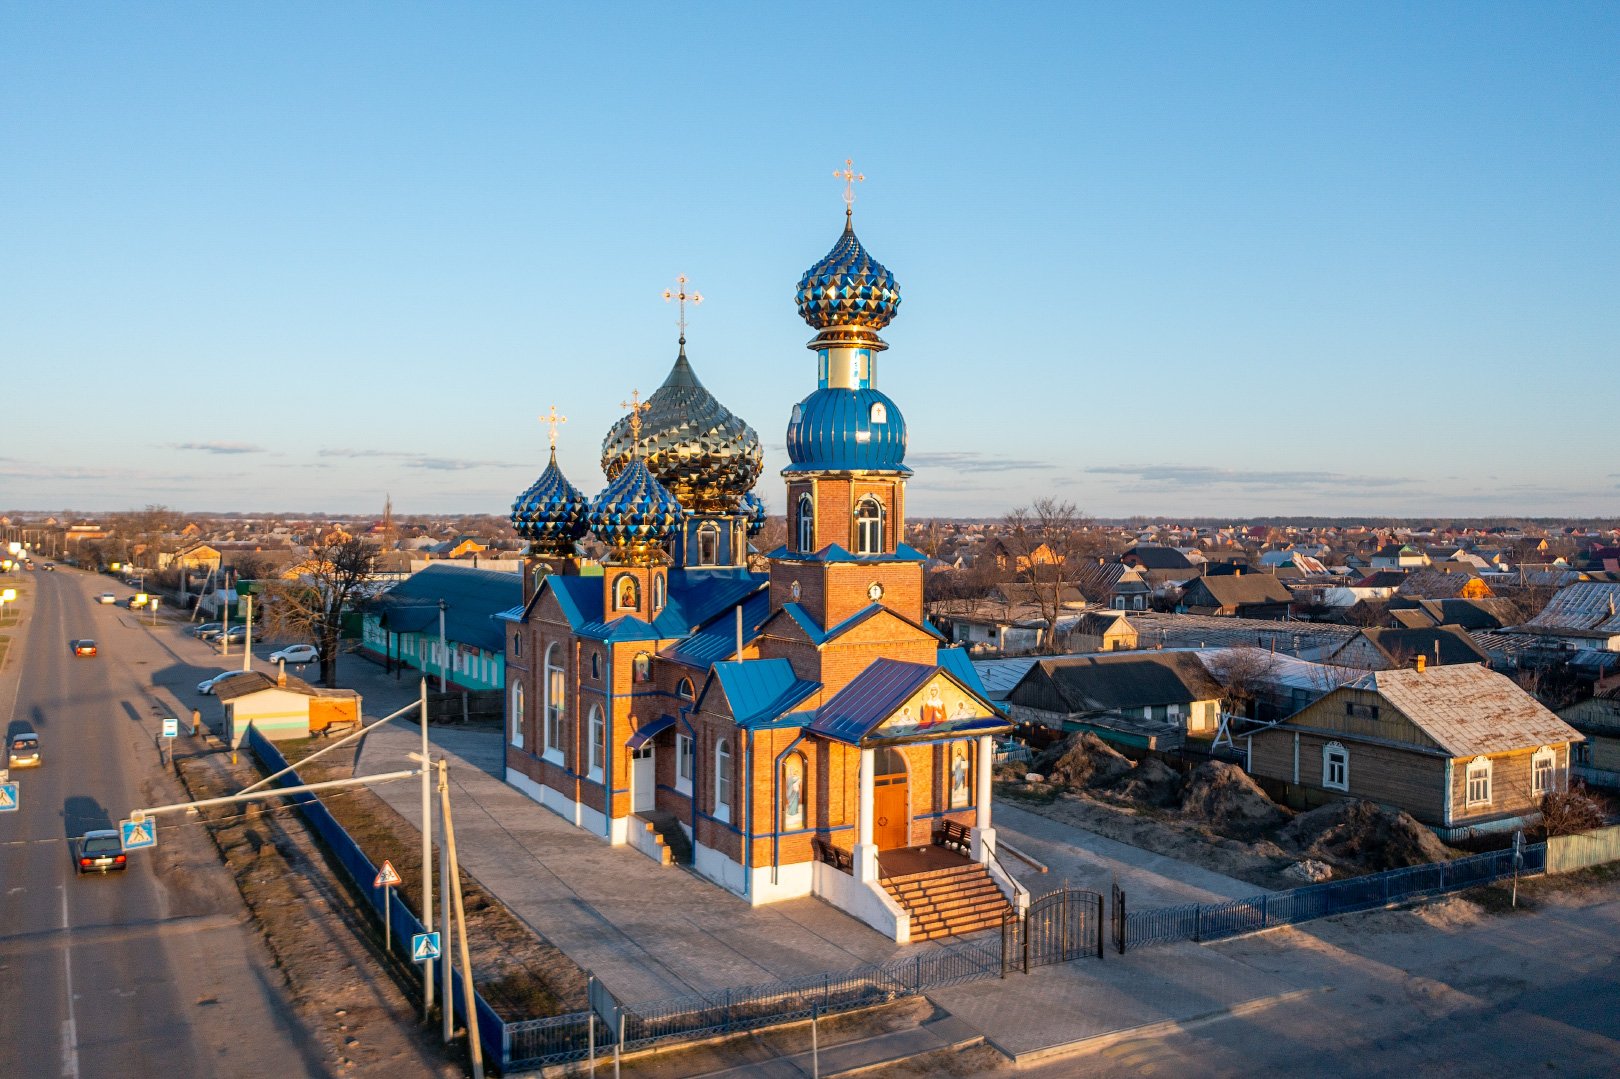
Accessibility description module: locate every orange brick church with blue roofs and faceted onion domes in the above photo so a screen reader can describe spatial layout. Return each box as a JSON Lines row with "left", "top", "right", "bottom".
{"left": 501, "top": 170, "right": 1027, "bottom": 943}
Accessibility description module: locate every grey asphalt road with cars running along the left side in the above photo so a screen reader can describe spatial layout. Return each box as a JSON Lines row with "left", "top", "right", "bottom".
{"left": 0, "top": 569, "right": 327, "bottom": 1079}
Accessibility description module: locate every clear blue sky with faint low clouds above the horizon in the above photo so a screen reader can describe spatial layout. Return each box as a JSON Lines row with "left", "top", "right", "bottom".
{"left": 0, "top": 2, "right": 1620, "bottom": 517}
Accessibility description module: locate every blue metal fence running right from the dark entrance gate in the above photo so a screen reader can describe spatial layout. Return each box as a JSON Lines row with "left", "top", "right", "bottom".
{"left": 1121, "top": 842, "right": 1547, "bottom": 948}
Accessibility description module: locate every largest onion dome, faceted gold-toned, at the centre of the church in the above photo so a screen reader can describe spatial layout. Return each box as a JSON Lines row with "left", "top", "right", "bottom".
{"left": 603, "top": 345, "right": 765, "bottom": 514}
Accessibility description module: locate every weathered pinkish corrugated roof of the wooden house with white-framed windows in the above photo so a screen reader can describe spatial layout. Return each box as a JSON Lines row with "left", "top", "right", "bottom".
{"left": 1349, "top": 663, "right": 1583, "bottom": 757}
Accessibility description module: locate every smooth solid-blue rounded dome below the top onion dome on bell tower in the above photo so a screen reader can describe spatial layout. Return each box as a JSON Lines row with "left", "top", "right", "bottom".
{"left": 787, "top": 387, "right": 910, "bottom": 473}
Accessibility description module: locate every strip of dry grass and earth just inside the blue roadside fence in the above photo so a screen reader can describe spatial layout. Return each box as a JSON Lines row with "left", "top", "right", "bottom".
{"left": 279, "top": 725, "right": 588, "bottom": 1021}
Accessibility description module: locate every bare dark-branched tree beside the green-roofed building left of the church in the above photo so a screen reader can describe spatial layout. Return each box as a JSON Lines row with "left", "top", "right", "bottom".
{"left": 262, "top": 533, "right": 379, "bottom": 685}
